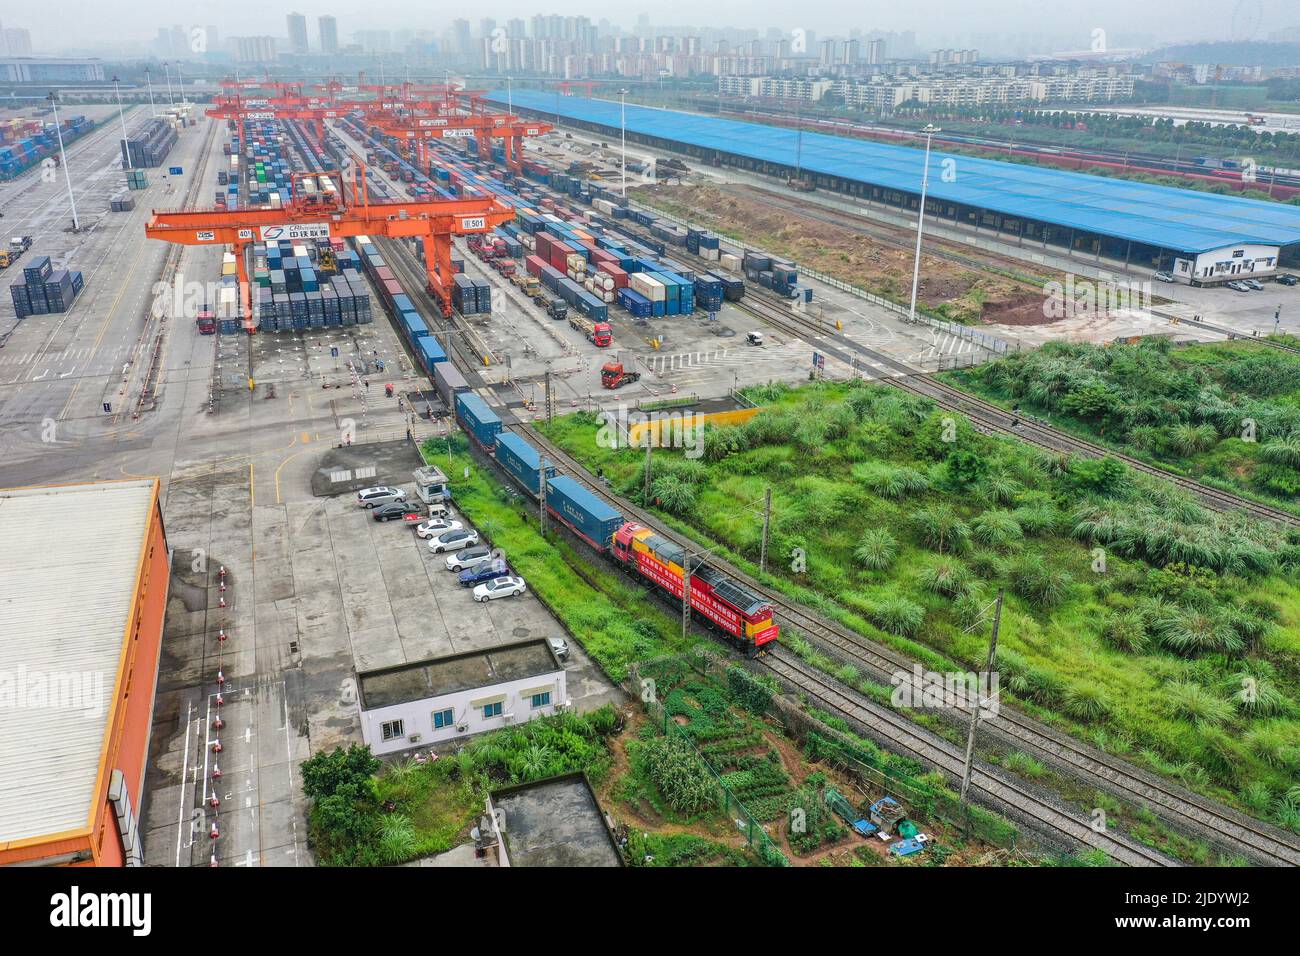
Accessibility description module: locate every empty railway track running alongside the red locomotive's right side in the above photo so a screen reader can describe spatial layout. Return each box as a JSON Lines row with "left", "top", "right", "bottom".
{"left": 514, "top": 423, "right": 1300, "bottom": 866}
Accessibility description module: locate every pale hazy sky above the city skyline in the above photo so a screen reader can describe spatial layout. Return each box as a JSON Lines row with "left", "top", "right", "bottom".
{"left": 0, "top": 0, "right": 1300, "bottom": 53}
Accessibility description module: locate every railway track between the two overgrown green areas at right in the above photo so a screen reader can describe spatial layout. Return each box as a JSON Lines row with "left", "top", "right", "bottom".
{"left": 735, "top": 295, "right": 1300, "bottom": 527}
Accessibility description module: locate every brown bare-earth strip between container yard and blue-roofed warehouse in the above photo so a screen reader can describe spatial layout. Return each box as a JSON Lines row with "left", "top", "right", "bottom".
{"left": 633, "top": 185, "right": 1048, "bottom": 325}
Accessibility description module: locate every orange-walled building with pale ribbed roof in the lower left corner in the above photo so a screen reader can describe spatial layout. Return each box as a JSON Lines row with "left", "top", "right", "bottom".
{"left": 0, "top": 479, "right": 169, "bottom": 866}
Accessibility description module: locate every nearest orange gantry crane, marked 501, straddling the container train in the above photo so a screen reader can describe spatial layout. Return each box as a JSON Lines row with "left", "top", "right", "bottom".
{"left": 144, "top": 166, "right": 515, "bottom": 323}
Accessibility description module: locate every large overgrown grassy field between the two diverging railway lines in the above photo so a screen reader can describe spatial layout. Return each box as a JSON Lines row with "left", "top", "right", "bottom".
{"left": 535, "top": 384, "right": 1300, "bottom": 825}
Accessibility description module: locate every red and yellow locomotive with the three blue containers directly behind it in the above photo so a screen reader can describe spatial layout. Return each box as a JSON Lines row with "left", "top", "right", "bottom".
{"left": 455, "top": 390, "right": 780, "bottom": 657}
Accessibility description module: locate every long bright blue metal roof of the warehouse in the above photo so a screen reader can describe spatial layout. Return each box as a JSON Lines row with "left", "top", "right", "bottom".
{"left": 489, "top": 90, "right": 1300, "bottom": 254}
